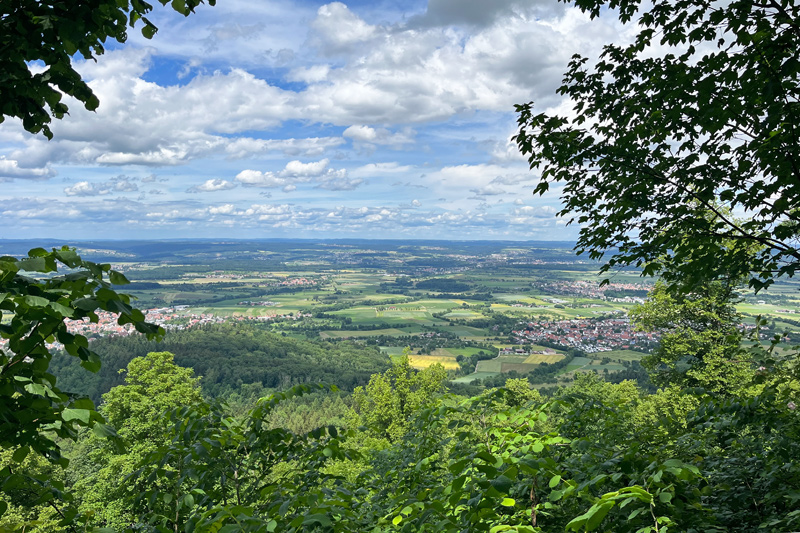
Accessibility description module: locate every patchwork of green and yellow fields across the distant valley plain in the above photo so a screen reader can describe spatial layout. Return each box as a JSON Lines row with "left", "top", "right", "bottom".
{"left": 90, "top": 243, "right": 800, "bottom": 383}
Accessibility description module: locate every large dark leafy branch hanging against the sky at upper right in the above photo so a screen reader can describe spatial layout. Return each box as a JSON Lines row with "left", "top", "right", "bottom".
{"left": 516, "top": 0, "right": 800, "bottom": 289}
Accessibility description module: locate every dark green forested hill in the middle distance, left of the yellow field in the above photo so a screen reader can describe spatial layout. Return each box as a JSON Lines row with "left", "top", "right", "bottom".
{"left": 50, "top": 323, "right": 389, "bottom": 403}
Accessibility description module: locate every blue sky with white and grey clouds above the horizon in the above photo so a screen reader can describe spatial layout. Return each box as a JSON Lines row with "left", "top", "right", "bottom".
{"left": 0, "top": 0, "right": 630, "bottom": 241}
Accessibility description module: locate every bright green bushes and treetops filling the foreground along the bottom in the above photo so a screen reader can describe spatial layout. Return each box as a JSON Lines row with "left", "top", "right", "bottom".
{"left": 0, "top": 340, "right": 800, "bottom": 533}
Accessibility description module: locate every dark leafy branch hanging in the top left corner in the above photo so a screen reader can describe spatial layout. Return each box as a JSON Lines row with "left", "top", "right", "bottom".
{"left": 0, "top": 0, "right": 216, "bottom": 139}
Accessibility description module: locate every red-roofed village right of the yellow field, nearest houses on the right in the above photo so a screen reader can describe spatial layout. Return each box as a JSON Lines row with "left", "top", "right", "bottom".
{"left": 512, "top": 318, "right": 659, "bottom": 353}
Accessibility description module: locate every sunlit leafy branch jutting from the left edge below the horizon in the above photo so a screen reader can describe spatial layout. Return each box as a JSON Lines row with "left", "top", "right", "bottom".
{"left": 0, "top": 247, "right": 164, "bottom": 460}
